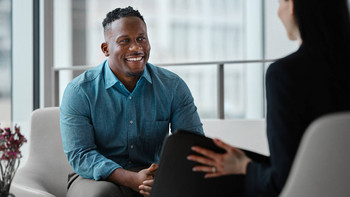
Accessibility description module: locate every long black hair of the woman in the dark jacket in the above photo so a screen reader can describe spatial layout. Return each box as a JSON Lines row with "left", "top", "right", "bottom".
{"left": 294, "top": 0, "right": 350, "bottom": 77}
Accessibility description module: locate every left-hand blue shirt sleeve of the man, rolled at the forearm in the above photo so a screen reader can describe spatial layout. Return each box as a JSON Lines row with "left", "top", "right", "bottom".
{"left": 60, "top": 83, "right": 121, "bottom": 180}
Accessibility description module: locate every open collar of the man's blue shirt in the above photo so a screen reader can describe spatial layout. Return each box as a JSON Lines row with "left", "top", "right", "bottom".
{"left": 104, "top": 59, "right": 152, "bottom": 89}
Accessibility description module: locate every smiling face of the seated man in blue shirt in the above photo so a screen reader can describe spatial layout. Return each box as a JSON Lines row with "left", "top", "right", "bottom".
{"left": 101, "top": 16, "right": 151, "bottom": 79}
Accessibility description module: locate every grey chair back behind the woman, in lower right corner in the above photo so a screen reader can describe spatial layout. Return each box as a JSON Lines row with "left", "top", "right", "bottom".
{"left": 281, "top": 112, "right": 350, "bottom": 197}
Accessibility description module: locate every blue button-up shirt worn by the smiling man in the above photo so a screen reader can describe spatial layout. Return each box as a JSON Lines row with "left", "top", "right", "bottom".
{"left": 60, "top": 60, "right": 204, "bottom": 180}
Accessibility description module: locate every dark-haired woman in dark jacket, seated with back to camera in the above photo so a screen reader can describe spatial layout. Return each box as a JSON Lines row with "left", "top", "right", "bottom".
{"left": 188, "top": 0, "right": 350, "bottom": 196}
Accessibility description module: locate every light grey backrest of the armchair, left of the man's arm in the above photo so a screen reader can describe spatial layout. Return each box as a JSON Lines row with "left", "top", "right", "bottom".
{"left": 24, "top": 107, "right": 73, "bottom": 197}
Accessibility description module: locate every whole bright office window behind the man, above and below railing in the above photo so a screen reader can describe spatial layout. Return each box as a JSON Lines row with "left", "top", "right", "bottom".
{"left": 54, "top": 0, "right": 294, "bottom": 118}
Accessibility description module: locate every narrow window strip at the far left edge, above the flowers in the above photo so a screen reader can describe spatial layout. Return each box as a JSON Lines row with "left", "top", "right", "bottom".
{"left": 0, "top": 0, "right": 11, "bottom": 123}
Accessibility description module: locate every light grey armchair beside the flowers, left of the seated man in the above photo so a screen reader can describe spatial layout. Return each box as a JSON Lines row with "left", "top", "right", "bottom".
{"left": 10, "top": 107, "right": 73, "bottom": 197}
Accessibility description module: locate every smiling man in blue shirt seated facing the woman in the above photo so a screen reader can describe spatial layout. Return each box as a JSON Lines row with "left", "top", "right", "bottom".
{"left": 60, "top": 7, "right": 203, "bottom": 197}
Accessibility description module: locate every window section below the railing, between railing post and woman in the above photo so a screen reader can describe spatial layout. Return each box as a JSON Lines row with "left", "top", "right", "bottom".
{"left": 224, "top": 63, "right": 264, "bottom": 119}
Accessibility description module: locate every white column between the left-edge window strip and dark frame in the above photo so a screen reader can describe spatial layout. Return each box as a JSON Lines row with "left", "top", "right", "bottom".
{"left": 12, "top": 0, "right": 33, "bottom": 165}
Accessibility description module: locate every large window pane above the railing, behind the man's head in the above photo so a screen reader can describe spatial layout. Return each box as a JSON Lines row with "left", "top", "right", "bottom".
{"left": 71, "top": 0, "right": 245, "bottom": 65}
